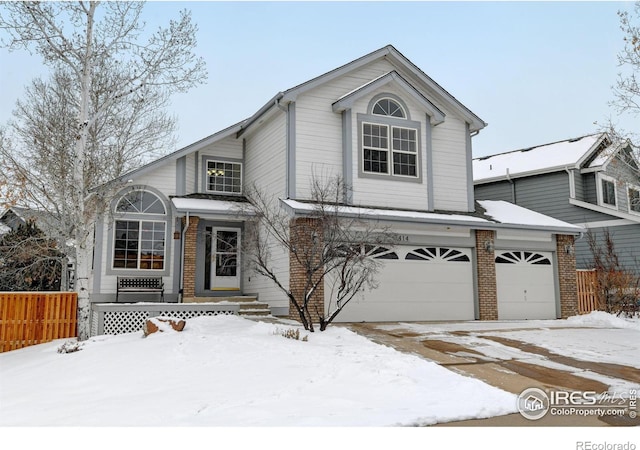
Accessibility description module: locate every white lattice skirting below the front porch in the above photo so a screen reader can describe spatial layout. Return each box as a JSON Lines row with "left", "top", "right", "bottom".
{"left": 91, "top": 303, "right": 240, "bottom": 336}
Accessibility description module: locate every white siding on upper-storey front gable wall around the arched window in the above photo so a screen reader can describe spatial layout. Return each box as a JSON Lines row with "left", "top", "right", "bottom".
{"left": 295, "top": 60, "right": 469, "bottom": 211}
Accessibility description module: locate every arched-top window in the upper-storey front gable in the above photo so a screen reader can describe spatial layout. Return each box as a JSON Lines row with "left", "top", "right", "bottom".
{"left": 360, "top": 97, "right": 420, "bottom": 179}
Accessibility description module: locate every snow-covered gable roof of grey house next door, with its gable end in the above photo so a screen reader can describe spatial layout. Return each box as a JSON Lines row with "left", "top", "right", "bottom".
{"left": 473, "top": 133, "right": 618, "bottom": 184}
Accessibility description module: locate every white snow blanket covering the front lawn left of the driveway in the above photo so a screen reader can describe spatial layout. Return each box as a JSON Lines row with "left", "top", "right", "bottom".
{"left": 0, "top": 316, "right": 516, "bottom": 427}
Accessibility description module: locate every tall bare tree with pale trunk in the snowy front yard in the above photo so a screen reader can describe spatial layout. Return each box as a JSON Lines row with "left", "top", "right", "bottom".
{"left": 0, "top": 1, "right": 206, "bottom": 340}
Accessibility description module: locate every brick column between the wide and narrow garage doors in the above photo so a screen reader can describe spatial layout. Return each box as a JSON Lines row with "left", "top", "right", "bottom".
{"left": 476, "top": 230, "right": 498, "bottom": 320}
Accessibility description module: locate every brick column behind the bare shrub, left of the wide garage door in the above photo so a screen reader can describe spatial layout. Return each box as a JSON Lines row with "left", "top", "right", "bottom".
{"left": 289, "top": 218, "right": 324, "bottom": 323}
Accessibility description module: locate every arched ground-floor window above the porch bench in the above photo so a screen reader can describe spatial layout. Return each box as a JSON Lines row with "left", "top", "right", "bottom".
{"left": 113, "top": 190, "right": 167, "bottom": 270}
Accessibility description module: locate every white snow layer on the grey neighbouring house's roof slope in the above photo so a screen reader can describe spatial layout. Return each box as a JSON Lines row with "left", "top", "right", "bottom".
{"left": 473, "top": 133, "right": 603, "bottom": 183}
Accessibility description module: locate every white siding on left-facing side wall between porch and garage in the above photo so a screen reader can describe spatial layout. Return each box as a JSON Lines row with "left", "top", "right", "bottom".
{"left": 243, "top": 112, "right": 289, "bottom": 307}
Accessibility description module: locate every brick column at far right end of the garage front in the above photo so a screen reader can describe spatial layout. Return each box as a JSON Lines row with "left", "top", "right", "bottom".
{"left": 556, "top": 234, "right": 578, "bottom": 319}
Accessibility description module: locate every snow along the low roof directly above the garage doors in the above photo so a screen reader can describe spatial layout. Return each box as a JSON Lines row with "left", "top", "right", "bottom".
{"left": 281, "top": 199, "right": 584, "bottom": 234}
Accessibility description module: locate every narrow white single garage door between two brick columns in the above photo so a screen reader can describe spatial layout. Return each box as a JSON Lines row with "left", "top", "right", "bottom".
{"left": 496, "top": 251, "right": 556, "bottom": 320}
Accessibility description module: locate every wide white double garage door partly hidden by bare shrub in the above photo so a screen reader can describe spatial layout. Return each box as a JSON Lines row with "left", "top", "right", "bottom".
{"left": 325, "top": 246, "right": 475, "bottom": 322}
